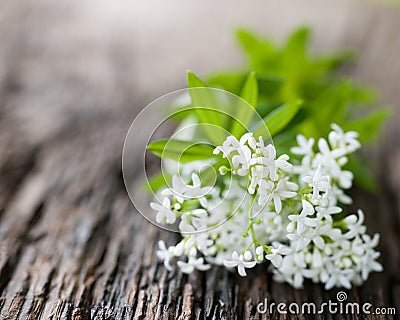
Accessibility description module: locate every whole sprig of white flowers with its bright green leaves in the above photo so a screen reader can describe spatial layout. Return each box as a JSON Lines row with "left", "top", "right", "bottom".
{"left": 148, "top": 28, "right": 388, "bottom": 289}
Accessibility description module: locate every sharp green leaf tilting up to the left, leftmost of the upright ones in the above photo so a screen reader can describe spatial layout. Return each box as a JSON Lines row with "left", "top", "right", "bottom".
{"left": 188, "top": 71, "right": 225, "bottom": 145}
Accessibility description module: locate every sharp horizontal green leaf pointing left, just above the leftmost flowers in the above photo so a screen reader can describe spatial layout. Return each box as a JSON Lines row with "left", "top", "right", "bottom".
{"left": 147, "top": 139, "right": 214, "bottom": 162}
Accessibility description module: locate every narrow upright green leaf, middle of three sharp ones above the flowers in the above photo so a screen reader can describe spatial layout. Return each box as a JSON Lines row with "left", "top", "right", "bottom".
{"left": 229, "top": 72, "right": 258, "bottom": 138}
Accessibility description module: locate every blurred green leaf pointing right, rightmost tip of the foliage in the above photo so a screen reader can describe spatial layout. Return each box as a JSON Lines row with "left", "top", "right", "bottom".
{"left": 343, "top": 108, "right": 390, "bottom": 142}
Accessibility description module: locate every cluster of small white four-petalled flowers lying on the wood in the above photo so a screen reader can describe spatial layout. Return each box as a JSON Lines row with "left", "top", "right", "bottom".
{"left": 151, "top": 125, "right": 382, "bottom": 289}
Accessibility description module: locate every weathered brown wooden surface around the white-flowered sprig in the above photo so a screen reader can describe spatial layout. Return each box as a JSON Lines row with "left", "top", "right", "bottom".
{"left": 0, "top": 0, "right": 400, "bottom": 320}
